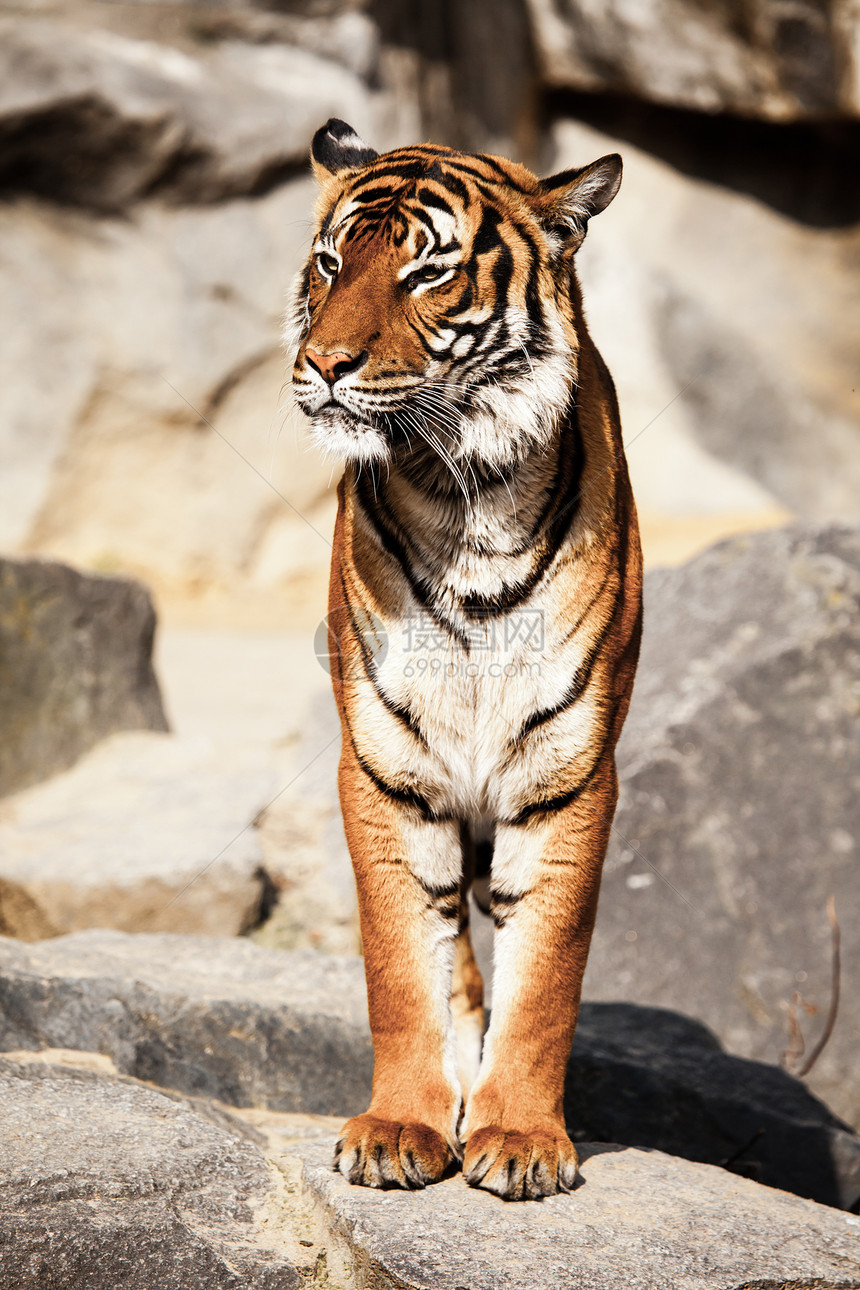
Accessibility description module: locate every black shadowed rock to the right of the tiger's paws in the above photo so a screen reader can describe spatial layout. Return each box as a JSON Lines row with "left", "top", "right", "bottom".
{"left": 565, "top": 1004, "right": 860, "bottom": 1211}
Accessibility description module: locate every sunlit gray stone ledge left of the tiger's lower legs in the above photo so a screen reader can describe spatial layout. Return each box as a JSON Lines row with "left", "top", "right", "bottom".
{"left": 0, "top": 931, "right": 373, "bottom": 1116}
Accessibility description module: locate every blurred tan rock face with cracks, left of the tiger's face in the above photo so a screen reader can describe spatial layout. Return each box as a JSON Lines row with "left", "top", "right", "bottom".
{"left": 0, "top": 181, "right": 331, "bottom": 591}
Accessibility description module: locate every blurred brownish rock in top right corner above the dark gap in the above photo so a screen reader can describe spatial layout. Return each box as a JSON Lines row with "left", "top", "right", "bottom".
{"left": 529, "top": 0, "right": 860, "bottom": 121}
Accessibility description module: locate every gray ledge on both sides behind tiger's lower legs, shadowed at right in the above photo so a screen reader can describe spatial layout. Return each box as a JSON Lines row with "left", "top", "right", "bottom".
{"left": 0, "top": 931, "right": 860, "bottom": 1207}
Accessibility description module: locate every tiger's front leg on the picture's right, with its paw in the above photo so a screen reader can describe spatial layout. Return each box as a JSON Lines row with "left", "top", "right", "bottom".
{"left": 463, "top": 761, "right": 616, "bottom": 1200}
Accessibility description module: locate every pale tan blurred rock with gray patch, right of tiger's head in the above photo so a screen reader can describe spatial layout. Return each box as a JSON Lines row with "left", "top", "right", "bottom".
{"left": 552, "top": 120, "right": 860, "bottom": 526}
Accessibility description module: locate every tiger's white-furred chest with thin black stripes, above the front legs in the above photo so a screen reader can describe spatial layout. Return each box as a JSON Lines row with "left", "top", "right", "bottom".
{"left": 351, "top": 559, "right": 600, "bottom": 818}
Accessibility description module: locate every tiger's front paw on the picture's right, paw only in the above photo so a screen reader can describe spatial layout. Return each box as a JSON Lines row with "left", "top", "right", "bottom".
{"left": 463, "top": 1125, "right": 579, "bottom": 1201}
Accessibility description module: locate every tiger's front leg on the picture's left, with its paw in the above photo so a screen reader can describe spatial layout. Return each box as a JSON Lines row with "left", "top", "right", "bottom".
{"left": 335, "top": 739, "right": 462, "bottom": 1188}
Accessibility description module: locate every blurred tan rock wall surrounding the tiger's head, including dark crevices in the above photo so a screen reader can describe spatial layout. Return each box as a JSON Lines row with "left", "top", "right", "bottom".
{"left": 0, "top": 0, "right": 860, "bottom": 608}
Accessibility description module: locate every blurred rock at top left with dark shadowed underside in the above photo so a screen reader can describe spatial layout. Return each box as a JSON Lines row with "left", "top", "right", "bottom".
{"left": 0, "top": 14, "right": 373, "bottom": 209}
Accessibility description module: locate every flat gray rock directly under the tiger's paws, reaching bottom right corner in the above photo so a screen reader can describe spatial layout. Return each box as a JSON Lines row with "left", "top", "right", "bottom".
{"left": 302, "top": 1144, "right": 860, "bottom": 1290}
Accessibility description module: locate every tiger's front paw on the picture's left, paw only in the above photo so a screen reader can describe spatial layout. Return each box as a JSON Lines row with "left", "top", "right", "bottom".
{"left": 334, "top": 1115, "right": 458, "bottom": 1191}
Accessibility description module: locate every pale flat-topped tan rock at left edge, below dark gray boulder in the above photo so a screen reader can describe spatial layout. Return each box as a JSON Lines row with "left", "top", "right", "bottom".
{"left": 0, "top": 733, "right": 277, "bottom": 939}
